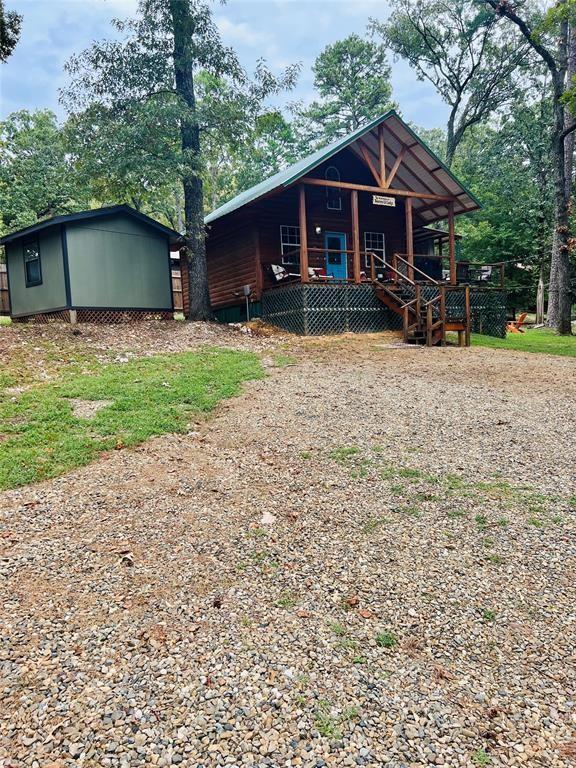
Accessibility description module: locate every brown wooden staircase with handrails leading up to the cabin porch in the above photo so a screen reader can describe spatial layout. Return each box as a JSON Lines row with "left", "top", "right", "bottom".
{"left": 372, "top": 252, "right": 470, "bottom": 347}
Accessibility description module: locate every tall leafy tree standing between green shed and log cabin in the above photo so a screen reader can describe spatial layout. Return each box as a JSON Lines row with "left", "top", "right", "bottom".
{"left": 62, "top": 0, "right": 296, "bottom": 320}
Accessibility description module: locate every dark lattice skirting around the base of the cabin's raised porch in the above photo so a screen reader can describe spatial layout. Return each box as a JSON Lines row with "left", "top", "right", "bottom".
{"left": 262, "top": 283, "right": 506, "bottom": 337}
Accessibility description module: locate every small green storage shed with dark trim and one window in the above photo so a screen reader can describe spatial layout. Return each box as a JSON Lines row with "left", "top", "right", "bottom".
{"left": 0, "top": 205, "right": 181, "bottom": 323}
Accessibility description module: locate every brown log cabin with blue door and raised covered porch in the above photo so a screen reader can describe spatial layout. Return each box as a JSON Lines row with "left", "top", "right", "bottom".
{"left": 183, "top": 110, "right": 505, "bottom": 345}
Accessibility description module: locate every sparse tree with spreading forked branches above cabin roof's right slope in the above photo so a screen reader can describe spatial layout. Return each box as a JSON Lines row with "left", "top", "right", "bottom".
{"left": 371, "top": 0, "right": 527, "bottom": 166}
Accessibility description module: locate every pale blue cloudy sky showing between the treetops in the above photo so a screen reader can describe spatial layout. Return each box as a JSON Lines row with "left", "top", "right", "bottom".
{"left": 0, "top": 0, "right": 447, "bottom": 128}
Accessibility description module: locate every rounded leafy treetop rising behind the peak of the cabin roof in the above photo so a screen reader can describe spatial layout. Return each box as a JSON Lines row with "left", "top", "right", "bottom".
{"left": 299, "top": 34, "right": 393, "bottom": 143}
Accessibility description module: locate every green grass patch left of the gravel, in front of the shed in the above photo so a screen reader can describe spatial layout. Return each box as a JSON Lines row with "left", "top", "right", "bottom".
{"left": 0, "top": 348, "right": 263, "bottom": 489}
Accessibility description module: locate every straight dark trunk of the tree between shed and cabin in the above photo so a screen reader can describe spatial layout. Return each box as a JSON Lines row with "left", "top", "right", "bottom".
{"left": 170, "top": 0, "right": 213, "bottom": 320}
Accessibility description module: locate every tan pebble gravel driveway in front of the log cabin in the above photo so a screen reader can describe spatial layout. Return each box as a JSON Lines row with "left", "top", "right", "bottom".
{"left": 0, "top": 328, "right": 576, "bottom": 768}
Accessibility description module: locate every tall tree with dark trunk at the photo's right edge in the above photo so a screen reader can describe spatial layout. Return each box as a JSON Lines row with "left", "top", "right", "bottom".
{"left": 484, "top": 0, "right": 576, "bottom": 334}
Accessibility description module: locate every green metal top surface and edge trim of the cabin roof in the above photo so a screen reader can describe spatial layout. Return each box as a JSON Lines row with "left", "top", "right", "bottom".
{"left": 205, "top": 109, "right": 480, "bottom": 224}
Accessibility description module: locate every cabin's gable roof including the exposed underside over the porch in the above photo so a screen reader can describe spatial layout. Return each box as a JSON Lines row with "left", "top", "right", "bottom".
{"left": 204, "top": 109, "right": 481, "bottom": 224}
